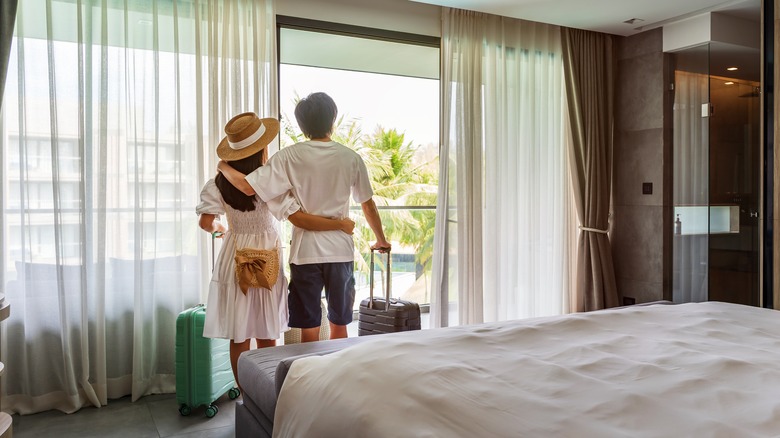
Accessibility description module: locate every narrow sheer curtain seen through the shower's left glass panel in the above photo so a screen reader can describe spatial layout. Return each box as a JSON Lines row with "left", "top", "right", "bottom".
{"left": 672, "top": 70, "right": 710, "bottom": 303}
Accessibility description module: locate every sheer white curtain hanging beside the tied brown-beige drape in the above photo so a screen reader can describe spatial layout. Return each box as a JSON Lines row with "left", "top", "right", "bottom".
{"left": 431, "top": 8, "right": 575, "bottom": 325}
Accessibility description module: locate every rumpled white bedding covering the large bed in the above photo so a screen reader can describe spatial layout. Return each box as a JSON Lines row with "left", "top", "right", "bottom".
{"left": 274, "top": 302, "right": 780, "bottom": 438}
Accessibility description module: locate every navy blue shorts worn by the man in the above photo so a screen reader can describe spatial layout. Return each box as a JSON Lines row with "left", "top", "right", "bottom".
{"left": 287, "top": 262, "right": 355, "bottom": 328}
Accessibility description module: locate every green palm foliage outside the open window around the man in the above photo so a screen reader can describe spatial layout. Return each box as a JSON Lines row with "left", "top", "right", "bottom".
{"left": 281, "top": 111, "right": 438, "bottom": 278}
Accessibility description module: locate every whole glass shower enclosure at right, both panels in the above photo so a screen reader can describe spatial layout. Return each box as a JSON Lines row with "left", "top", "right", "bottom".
{"left": 672, "top": 42, "right": 761, "bottom": 305}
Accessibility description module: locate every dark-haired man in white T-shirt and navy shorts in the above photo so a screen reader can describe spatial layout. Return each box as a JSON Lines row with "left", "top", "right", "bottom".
{"left": 218, "top": 93, "right": 390, "bottom": 342}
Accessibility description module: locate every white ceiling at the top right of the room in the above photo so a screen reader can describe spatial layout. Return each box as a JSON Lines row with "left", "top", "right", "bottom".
{"left": 412, "top": 0, "right": 761, "bottom": 36}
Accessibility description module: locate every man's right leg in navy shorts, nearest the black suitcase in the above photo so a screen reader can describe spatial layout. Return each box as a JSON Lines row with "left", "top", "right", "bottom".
{"left": 323, "top": 262, "right": 355, "bottom": 339}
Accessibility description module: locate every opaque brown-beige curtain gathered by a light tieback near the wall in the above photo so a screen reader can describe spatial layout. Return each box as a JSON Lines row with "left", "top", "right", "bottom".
{"left": 561, "top": 28, "right": 620, "bottom": 312}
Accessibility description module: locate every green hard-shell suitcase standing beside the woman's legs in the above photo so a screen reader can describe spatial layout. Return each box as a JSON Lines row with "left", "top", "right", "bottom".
{"left": 176, "top": 304, "right": 241, "bottom": 418}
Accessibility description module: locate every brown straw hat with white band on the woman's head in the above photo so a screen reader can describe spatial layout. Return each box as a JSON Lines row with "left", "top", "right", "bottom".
{"left": 217, "top": 112, "right": 279, "bottom": 161}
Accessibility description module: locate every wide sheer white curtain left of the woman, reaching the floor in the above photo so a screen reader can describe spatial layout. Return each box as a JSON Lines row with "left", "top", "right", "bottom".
{"left": 0, "top": 0, "right": 277, "bottom": 413}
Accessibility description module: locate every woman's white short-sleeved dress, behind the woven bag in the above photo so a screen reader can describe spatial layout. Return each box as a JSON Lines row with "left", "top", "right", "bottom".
{"left": 196, "top": 179, "right": 289, "bottom": 342}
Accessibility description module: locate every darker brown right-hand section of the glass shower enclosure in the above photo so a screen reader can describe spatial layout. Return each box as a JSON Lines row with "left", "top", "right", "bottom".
{"left": 709, "top": 75, "right": 761, "bottom": 306}
